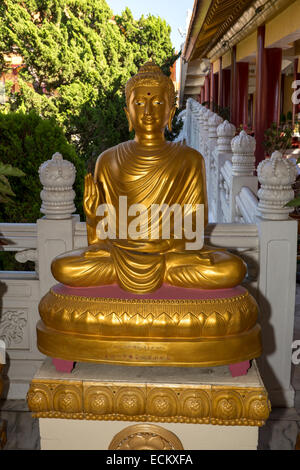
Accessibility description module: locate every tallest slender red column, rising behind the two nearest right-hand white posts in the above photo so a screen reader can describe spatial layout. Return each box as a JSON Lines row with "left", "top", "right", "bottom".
{"left": 255, "top": 25, "right": 267, "bottom": 164}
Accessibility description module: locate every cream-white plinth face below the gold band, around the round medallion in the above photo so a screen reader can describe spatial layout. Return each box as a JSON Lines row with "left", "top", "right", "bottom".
{"left": 39, "top": 418, "right": 258, "bottom": 450}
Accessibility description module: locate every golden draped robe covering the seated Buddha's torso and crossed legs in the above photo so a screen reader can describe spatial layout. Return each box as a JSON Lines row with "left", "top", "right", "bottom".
{"left": 52, "top": 141, "right": 246, "bottom": 294}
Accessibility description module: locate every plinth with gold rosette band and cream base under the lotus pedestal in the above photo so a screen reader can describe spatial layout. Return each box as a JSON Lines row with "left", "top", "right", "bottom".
{"left": 27, "top": 359, "right": 270, "bottom": 450}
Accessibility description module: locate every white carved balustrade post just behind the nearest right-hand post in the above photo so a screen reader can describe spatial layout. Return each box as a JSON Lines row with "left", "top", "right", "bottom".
{"left": 230, "top": 131, "right": 258, "bottom": 222}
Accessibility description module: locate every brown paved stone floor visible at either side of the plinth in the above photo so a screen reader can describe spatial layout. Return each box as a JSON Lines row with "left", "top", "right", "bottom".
{"left": 0, "top": 284, "right": 300, "bottom": 450}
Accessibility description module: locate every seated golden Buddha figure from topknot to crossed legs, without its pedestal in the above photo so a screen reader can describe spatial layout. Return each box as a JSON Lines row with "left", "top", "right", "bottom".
{"left": 52, "top": 62, "right": 246, "bottom": 294}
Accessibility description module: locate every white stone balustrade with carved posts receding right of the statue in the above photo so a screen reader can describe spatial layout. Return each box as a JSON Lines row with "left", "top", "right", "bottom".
{"left": 186, "top": 100, "right": 298, "bottom": 406}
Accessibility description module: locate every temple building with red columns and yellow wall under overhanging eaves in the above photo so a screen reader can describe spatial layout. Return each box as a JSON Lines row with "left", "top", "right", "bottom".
{"left": 180, "top": 0, "right": 300, "bottom": 163}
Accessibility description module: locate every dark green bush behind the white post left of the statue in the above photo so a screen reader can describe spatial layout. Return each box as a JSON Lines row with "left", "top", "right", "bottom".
{"left": 0, "top": 111, "right": 84, "bottom": 222}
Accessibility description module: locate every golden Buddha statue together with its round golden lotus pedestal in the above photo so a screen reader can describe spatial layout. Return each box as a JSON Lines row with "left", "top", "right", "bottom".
{"left": 37, "top": 63, "right": 261, "bottom": 367}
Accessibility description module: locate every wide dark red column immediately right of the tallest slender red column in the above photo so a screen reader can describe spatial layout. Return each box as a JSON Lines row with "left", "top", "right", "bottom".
{"left": 265, "top": 48, "right": 282, "bottom": 129}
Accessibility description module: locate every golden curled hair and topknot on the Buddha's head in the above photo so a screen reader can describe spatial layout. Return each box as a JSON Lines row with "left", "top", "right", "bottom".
{"left": 125, "top": 62, "right": 175, "bottom": 106}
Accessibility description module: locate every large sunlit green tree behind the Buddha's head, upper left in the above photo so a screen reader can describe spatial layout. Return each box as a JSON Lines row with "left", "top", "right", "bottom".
{"left": 0, "top": 0, "right": 177, "bottom": 163}
